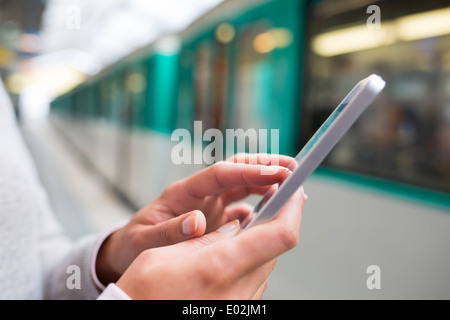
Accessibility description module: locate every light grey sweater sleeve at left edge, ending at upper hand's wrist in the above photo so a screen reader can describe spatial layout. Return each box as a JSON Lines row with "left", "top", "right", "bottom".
{"left": 0, "top": 81, "right": 100, "bottom": 299}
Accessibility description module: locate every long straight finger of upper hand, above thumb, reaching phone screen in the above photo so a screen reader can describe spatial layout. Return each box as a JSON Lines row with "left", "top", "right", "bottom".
{"left": 180, "top": 161, "right": 289, "bottom": 198}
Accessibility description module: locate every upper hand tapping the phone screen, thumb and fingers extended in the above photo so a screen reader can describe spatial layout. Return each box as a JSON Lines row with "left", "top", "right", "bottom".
{"left": 96, "top": 154, "right": 293, "bottom": 284}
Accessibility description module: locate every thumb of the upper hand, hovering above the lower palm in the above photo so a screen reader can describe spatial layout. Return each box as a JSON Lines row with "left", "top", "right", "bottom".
{"left": 142, "top": 210, "right": 206, "bottom": 248}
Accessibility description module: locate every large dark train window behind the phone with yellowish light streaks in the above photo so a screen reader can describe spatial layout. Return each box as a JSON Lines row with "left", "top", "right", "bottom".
{"left": 301, "top": 0, "right": 450, "bottom": 193}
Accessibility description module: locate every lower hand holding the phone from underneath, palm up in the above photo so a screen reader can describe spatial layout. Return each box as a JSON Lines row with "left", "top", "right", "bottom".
{"left": 116, "top": 185, "right": 305, "bottom": 299}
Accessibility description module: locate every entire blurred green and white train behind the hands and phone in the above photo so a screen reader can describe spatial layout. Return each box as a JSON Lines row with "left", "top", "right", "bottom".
{"left": 51, "top": 0, "right": 450, "bottom": 299}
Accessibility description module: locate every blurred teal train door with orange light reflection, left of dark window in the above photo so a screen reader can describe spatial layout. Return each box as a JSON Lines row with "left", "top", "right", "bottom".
{"left": 227, "top": 1, "right": 302, "bottom": 155}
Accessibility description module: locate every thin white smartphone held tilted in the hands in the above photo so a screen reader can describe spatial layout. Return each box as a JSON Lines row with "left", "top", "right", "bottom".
{"left": 243, "top": 74, "right": 386, "bottom": 229}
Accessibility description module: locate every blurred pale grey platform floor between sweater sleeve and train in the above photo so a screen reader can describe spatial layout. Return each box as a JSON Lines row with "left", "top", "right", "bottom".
{"left": 21, "top": 120, "right": 133, "bottom": 239}
